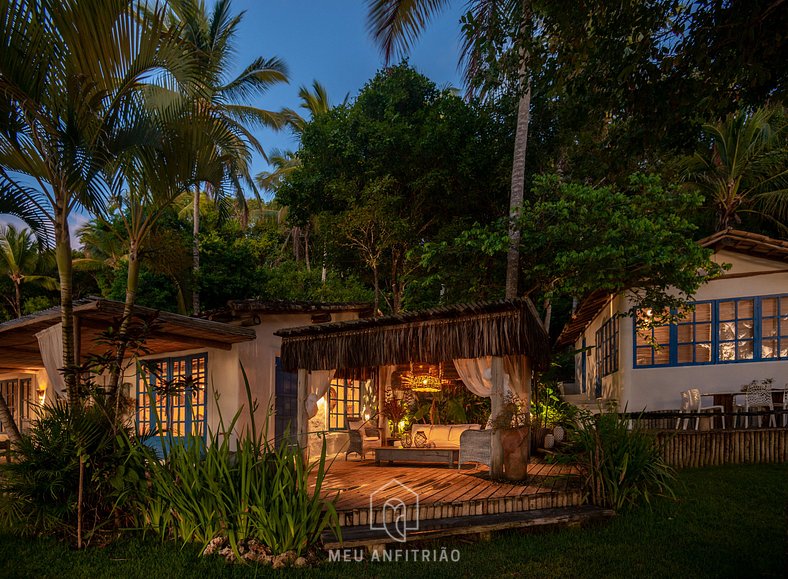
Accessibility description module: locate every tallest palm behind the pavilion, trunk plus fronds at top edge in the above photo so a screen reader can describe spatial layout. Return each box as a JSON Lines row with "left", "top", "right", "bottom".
{"left": 367, "top": 0, "right": 532, "bottom": 299}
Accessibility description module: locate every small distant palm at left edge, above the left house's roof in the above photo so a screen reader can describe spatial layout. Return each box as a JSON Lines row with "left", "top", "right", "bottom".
{"left": 0, "top": 225, "right": 58, "bottom": 318}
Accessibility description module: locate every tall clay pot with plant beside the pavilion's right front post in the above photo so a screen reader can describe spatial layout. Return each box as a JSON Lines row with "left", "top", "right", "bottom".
{"left": 492, "top": 392, "right": 531, "bottom": 480}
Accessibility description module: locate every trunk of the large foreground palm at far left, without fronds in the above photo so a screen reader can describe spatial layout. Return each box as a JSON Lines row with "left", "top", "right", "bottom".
{"left": 55, "top": 213, "right": 79, "bottom": 408}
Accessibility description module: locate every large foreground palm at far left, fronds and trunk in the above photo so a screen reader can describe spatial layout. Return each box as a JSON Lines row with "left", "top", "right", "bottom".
{"left": 0, "top": 0, "right": 194, "bottom": 404}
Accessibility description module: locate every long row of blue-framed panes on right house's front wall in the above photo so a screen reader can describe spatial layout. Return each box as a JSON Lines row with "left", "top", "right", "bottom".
{"left": 633, "top": 295, "right": 788, "bottom": 368}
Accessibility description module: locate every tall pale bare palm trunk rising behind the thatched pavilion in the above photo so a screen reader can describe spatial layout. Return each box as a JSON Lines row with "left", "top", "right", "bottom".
{"left": 506, "top": 0, "right": 531, "bottom": 299}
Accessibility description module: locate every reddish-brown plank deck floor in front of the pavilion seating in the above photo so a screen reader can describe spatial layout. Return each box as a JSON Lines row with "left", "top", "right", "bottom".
{"left": 323, "top": 458, "right": 582, "bottom": 527}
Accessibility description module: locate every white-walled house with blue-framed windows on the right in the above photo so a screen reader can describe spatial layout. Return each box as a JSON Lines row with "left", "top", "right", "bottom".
{"left": 557, "top": 229, "right": 788, "bottom": 411}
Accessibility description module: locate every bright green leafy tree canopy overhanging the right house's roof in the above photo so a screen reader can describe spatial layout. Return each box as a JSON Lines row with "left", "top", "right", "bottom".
{"left": 423, "top": 175, "right": 723, "bottom": 324}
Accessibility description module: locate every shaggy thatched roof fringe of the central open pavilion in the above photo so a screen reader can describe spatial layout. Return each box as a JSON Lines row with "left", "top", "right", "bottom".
{"left": 276, "top": 299, "right": 550, "bottom": 370}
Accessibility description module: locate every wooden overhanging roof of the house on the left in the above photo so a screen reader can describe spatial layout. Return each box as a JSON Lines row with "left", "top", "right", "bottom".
{"left": 0, "top": 298, "right": 255, "bottom": 372}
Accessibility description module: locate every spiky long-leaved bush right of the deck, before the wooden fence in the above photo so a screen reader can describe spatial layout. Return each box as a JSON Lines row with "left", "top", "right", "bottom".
{"left": 559, "top": 409, "right": 676, "bottom": 511}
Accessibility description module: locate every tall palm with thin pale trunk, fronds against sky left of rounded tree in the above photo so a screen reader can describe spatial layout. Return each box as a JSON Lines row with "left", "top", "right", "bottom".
{"left": 171, "top": 0, "right": 287, "bottom": 313}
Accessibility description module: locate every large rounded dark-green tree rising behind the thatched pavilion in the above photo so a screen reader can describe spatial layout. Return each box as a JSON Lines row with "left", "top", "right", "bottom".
{"left": 276, "top": 63, "right": 511, "bottom": 311}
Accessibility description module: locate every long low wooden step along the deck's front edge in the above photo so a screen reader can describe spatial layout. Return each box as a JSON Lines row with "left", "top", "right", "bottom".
{"left": 322, "top": 505, "right": 615, "bottom": 550}
